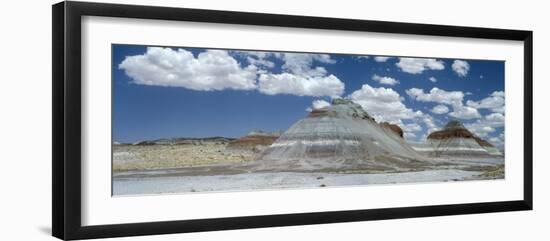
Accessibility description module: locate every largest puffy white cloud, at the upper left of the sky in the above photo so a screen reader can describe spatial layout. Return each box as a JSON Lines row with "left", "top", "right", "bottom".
{"left": 118, "top": 47, "right": 257, "bottom": 91}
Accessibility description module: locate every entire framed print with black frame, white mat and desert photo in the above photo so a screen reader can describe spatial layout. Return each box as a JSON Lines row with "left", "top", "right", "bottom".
{"left": 52, "top": 1, "right": 533, "bottom": 239}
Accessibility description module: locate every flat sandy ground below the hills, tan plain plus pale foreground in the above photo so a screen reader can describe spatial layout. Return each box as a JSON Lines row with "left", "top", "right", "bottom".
{"left": 113, "top": 143, "right": 504, "bottom": 195}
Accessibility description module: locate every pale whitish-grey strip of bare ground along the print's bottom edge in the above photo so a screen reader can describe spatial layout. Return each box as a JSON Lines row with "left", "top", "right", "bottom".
{"left": 113, "top": 170, "right": 481, "bottom": 195}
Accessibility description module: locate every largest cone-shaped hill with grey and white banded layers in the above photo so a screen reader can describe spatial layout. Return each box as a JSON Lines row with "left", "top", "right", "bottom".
{"left": 260, "top": 99, "right": 422, "bottom": 170}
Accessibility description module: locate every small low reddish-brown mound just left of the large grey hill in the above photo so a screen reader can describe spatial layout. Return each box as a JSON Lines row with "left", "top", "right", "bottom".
{"left": 225, "top": 130, "right": 282, "bottom": 152}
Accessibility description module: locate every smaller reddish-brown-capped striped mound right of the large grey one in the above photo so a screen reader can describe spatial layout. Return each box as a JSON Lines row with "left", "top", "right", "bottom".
{"left": 413, "top": 120, "right": 502, "bottom": 157}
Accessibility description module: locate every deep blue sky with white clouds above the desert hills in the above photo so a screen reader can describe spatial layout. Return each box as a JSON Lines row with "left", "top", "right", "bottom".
{"left": 112, "top": 45, "right": 504, "bottom": 146}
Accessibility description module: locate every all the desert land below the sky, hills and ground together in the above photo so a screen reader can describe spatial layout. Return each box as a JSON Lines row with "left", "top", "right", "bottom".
{"left": 113, "top": 99, "right": 504, "bottom": 195}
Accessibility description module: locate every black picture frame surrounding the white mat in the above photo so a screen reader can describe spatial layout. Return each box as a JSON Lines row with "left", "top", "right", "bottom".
{"left": 52, "top": 2, "right": 533, "bottom": 240}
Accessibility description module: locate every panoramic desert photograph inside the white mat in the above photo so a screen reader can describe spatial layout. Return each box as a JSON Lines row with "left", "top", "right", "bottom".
{"left": 111, "top": 44, "right": 505, "bottom": 196}
